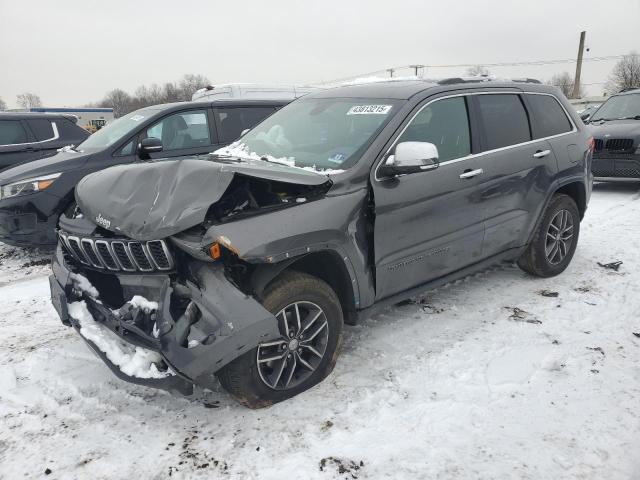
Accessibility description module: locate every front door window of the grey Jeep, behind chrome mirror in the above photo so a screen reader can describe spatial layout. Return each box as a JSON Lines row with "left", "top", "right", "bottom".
{"left": 397, "top": 97, "right": 471, "bottom": 162}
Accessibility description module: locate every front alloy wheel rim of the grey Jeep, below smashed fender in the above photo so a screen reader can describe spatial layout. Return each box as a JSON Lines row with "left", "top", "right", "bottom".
{"left": 256, "top": 301, "right": 329, "bottom": 390}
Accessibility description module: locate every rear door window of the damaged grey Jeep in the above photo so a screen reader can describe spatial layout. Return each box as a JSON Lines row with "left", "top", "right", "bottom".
{"left": 476, "top": 94, "right": 531, "bottom": 150}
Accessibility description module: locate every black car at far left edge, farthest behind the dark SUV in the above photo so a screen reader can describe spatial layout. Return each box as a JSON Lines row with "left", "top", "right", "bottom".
{"left": 0, "top": 113, "right": 89, "bottom": 172}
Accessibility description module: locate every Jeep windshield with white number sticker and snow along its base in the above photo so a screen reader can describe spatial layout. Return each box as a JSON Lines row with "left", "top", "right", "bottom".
{"left": 215, "top": 98, "right": 398, "bottom": 173}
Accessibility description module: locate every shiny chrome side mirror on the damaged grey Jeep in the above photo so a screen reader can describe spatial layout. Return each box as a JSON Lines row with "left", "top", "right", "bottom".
{"left": 378, "top": 142, "right": 440, "bottom": 177}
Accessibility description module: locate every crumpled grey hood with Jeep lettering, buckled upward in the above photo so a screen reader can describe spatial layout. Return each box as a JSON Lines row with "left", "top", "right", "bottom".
{"left": 76, "top": 158, "right": 329, "bottom": 241}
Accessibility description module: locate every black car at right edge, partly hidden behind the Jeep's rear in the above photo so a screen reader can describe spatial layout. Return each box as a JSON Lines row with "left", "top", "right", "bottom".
{"left": 588, "top": 89, "right": 640, "bottom": 178}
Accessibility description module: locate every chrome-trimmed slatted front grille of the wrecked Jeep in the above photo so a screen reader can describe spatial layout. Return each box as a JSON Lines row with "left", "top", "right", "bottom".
{"left": 58, "top": 231, "right": 174, "bottom": 272}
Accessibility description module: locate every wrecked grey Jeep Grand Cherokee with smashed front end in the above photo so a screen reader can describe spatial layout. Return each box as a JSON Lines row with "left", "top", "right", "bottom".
{"left": 51, "top": 80, "right": 593, "bottom": 407}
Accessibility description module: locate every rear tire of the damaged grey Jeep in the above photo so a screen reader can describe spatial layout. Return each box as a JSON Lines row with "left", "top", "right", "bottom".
{"left": 518, "top": 194, "right": 580, "bottom": 278}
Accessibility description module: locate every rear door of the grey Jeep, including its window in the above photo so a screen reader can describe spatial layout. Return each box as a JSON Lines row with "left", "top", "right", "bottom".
{"left": 471, "top": 92, "right": 557, "bottom": 257}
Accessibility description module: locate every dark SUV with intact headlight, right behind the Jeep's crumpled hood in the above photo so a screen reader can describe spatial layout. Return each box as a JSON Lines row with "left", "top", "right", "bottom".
{"left": 0, "top": 100, "right": 288, "bottom": 246}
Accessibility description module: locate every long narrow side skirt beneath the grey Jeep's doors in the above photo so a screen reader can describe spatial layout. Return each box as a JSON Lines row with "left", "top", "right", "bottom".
{"left": 357, "top": 245, "right": 527, "bottom": 322}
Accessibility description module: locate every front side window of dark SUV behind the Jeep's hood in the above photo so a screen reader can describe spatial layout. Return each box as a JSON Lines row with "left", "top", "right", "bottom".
{"left": 145, "top": 110, "right": 211, "bottom": 152}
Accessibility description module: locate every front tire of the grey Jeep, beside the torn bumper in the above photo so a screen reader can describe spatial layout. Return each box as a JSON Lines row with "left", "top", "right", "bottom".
{"left": 217, "top": 271, "right": 343, "bottom": 408}
